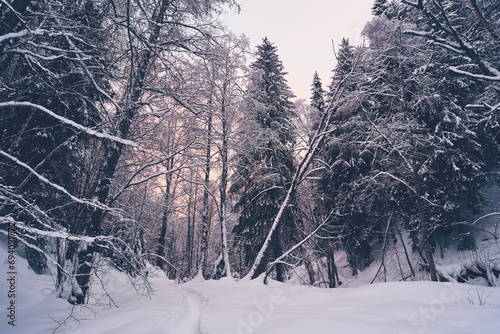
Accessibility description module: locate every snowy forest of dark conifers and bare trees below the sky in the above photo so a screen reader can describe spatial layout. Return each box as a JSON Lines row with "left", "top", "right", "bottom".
{"left": 0, "top": 0, "right": 500, "bottom": 307}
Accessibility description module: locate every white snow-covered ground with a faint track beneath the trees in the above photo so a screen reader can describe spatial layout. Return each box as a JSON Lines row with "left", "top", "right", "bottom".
{"left": 0, "top": 243, "right": 500, "bottom": 334}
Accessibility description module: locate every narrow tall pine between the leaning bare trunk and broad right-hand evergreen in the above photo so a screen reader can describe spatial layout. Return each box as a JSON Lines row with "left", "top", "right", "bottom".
{"left": 317, "top": 39, "right": 371, "bottom": 280}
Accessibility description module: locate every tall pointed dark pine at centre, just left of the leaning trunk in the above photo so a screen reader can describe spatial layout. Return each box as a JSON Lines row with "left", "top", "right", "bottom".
{"left": 231, "top": 38, "right": 295, "bottom": 281}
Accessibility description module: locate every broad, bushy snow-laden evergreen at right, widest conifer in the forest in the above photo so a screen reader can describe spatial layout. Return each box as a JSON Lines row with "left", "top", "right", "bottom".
{"left": 358, "top": 17, "right": 498, "bottom": 280}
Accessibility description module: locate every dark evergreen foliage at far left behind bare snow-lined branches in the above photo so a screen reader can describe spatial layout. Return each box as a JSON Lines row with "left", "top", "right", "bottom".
{"left": 0, "top": 0, "right": 110, "bottom": 271}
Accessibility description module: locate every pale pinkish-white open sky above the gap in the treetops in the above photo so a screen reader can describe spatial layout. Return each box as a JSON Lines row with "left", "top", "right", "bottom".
{"left": 221, "top": 0, "right": 374, "bottom": 100}
